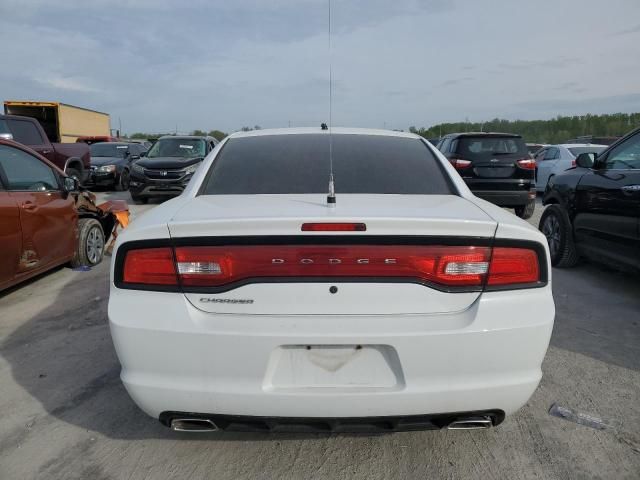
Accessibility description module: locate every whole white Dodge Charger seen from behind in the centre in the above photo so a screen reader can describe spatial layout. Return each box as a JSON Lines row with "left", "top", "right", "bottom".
{"left": 109, "top": 128, "right": 554, "bottom": 432}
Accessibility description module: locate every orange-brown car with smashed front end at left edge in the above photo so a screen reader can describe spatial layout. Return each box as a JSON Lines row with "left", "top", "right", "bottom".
{"left": 0, "top": 137, "right": 128, "bottom": 290}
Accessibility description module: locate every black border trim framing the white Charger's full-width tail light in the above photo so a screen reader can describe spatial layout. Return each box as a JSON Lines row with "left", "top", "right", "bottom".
{"left": 113, "top": 235, "right": 549, "bottom": 294}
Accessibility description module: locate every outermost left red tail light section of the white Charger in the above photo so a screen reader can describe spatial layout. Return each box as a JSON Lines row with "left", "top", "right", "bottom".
{"left": 122, "top": 247, "right": 178, "bottom": 285}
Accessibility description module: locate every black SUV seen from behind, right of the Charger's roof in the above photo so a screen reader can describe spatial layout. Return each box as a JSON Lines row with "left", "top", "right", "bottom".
{"left": 438, "top": 133, "right": 536, "bottom": 218}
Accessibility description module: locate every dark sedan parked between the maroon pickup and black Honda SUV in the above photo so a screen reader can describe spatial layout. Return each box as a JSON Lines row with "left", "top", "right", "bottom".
{"left": 87, "top": 142, "right": 146, "bottom": 190}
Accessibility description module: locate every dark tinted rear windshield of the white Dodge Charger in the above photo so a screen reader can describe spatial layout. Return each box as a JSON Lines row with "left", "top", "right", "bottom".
{"left": 203, "top": 134, "right": 452, "bottom": 195}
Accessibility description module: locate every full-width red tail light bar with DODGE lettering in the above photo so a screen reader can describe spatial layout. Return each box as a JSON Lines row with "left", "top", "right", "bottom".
{"left": 116, "top": 245, "right": 540, "bottom": 291}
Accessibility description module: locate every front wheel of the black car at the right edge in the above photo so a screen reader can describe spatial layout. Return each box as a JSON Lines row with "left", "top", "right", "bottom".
{"left": 538, "top": 205, "right": 580, "bottom": 267}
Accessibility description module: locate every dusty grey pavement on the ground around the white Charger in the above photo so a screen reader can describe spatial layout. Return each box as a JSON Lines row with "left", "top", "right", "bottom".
{"left": 0, "top": 193, "right": 640, "bottom": 480}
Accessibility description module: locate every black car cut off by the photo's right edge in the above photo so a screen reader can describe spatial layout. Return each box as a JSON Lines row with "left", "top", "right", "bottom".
{"left": 540, "top": 129, "right": 640, "bottom": 270}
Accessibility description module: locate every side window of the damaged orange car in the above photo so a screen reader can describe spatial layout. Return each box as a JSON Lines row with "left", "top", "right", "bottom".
{"left": 0, "top": 145, "right": 59, "bottom": 192}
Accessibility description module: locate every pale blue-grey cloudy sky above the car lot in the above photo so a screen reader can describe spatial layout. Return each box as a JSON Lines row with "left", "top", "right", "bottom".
{"left": 0, "top": 0, "right": 640, "bottom": 133}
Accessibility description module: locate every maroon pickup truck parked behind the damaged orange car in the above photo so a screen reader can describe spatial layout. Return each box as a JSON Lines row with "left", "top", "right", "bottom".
{"left": 0, "top": 115, "right": 91, "bottom": 183}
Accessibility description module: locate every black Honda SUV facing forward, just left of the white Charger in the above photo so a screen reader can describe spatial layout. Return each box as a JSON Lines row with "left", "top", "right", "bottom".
{"left": 129, "top": 135, "right": 218, "bottom": 203}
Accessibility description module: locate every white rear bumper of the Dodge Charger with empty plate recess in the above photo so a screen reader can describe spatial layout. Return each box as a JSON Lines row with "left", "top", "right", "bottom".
{"left": 109, "top": 285, "right": 554, "bottom": 420}
